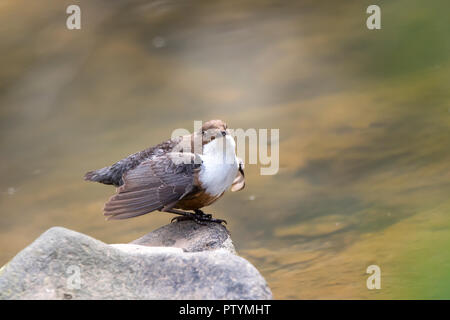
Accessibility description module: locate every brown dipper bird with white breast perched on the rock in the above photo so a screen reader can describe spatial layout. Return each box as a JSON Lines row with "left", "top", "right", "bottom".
{"left": 84, "top": 120, "right": 245, "bottom": 224}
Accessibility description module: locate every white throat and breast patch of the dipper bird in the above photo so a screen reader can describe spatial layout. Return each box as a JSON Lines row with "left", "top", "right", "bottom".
{"left": 199, "top": 135, "right": 239, "bottom": 196}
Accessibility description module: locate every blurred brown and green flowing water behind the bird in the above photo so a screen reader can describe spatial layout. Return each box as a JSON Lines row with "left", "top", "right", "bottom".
{"left": 0, "top": 0, "right": 450, "bottom": 299}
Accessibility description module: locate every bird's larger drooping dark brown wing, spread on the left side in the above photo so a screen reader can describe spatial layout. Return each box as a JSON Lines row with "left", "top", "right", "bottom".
{"left": 104, "top": 152, "right": 201, "bottom": 219}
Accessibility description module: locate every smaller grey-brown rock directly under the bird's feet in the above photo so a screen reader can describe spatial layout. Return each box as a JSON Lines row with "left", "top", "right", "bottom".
{"left": 130, "top": 221, "right": 236, "bottom": 254}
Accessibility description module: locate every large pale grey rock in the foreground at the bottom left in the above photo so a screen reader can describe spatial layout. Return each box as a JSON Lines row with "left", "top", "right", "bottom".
{"left": 0, "top": 226, "right": 272, "bottom": 299}
